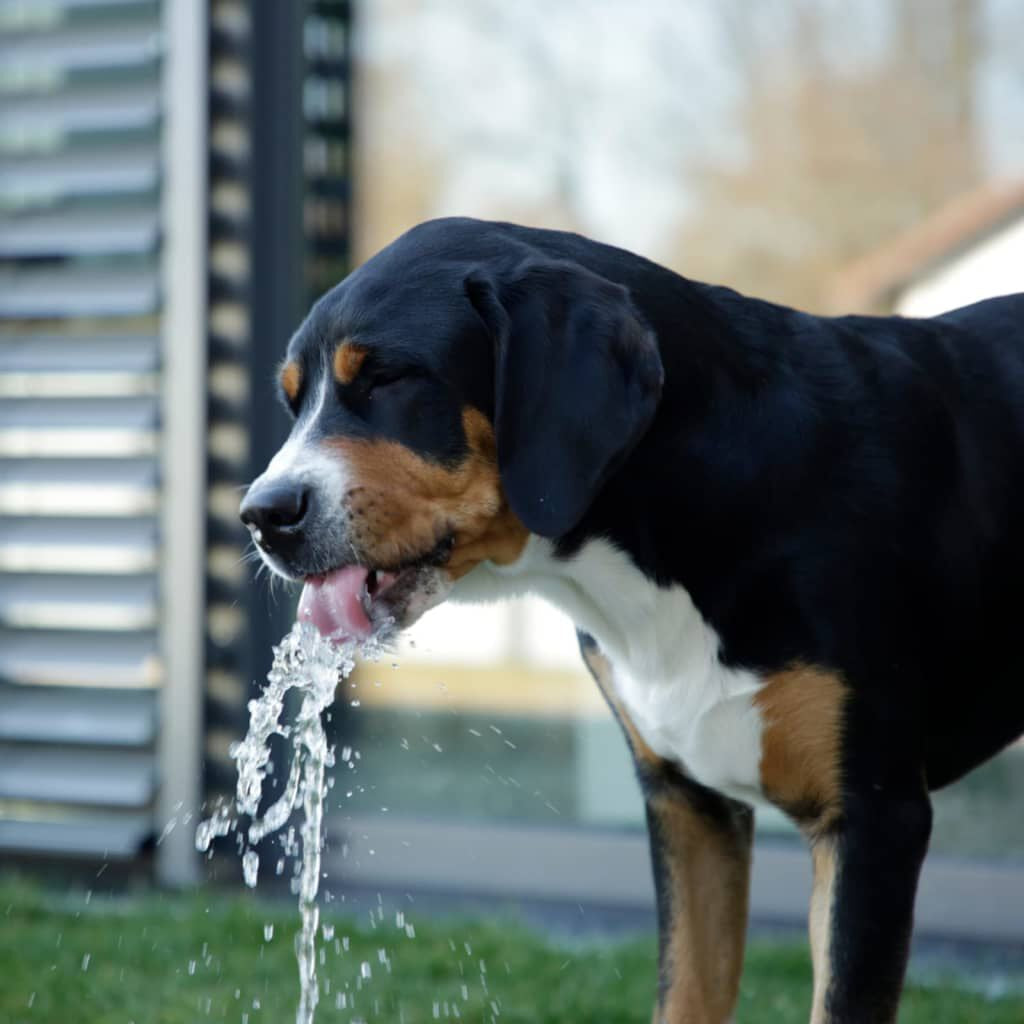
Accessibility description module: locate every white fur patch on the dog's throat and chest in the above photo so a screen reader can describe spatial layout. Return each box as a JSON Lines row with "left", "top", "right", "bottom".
{"left": 452, "top": 537, "right": 761, "bottom": 801}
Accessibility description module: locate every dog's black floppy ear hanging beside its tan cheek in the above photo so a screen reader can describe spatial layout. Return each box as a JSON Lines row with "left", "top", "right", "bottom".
{"left": 465, "top": 260, "right": 663, "bottom": 538}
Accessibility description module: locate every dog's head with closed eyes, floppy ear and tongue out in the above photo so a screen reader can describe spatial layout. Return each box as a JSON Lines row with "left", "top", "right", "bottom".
{"left": 241, "top": 220, "right": 662, "bottom": 638}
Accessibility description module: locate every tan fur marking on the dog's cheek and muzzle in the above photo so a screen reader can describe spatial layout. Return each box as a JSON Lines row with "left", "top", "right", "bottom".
{"left": 328, "top": 409, "right": 527, "bottom": 579}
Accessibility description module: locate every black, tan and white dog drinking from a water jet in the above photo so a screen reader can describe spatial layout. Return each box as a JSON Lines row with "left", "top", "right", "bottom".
{"left": 241, "top": 218, "right": 1024, "bottom": 1024}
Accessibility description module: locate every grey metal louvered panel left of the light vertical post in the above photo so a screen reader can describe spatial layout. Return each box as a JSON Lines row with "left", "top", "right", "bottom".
{"left": 0, "top": 0, "right": 173, "bottom": 856}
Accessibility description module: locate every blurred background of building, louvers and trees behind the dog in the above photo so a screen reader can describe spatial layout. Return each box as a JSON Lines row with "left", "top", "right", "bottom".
{"left": 0, "top": 0, "right": 1024, "bottom": 942}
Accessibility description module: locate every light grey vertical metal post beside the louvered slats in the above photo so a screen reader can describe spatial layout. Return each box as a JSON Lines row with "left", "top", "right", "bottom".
{"left": 156, "top": 0, "right": 209, "bottom": 885}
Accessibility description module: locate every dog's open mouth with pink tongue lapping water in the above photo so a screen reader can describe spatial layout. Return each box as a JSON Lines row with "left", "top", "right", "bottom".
{"left": 298, "top": 535, "right": 455, "bottom": 643}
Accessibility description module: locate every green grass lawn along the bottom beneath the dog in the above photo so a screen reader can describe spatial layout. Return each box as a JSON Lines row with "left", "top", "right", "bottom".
{"left": 0, "top": 884, "right": 1024, "bottom": 1024}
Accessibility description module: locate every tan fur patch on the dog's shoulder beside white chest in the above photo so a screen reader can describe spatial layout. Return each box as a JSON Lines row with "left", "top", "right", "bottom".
{"left": 754, "top": 666, "right": 847, "bottom": 835}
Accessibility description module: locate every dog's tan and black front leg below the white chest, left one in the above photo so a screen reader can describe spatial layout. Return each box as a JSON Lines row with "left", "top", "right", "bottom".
{"left": 580, "top": 634, "right": 754, "bottom": 1024}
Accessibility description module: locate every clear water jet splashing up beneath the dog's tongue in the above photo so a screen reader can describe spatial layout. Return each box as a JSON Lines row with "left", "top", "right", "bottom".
{"left": 196, "top": 623, "right": 381, "bottom": 1024}
